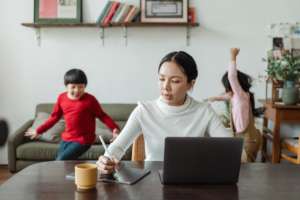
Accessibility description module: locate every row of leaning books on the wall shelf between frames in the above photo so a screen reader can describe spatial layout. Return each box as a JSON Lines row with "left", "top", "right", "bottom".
{"left": 96, "top": 1, "right": 140, "bottom": 26}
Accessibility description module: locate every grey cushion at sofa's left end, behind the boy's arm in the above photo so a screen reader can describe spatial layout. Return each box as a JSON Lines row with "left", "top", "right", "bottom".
{"left": 31, "top": 112, "right": 65, "bottom": 143}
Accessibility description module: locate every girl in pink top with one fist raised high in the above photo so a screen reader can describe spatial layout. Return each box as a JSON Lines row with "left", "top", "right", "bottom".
{"left": 209, "top": 48, "right": 261, "bottom": 162}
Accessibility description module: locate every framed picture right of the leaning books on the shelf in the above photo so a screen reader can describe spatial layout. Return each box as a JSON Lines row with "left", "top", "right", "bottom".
{"left": 141, "top": 0, "right": 188, "bottom": 23}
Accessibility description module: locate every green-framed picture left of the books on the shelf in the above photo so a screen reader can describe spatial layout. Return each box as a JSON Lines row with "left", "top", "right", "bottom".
{"left": 34, "top": 0, "right": 82, "bottom": 24}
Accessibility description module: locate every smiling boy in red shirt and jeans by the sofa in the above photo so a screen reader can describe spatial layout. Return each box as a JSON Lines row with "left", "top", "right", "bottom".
{"left": 25, "top": 69, "right": 119, "bottom": 160}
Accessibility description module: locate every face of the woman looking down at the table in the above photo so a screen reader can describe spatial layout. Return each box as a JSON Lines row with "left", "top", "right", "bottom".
{"left": 159, "top": 61, "right": 195, "bottom": 106}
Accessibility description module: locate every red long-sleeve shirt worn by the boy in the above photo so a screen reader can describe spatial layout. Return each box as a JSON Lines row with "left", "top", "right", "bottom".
{"left": 36, "top": 92, "right": 119, "bottom": 144}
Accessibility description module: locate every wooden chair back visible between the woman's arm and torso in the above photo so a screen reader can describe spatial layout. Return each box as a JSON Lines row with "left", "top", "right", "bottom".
{"left": 131, "top": 134, "right": 145, "bottom": 161}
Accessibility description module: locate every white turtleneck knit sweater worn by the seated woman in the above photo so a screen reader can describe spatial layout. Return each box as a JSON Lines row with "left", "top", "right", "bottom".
{"left": 105, "top": 96, "right": 233, "bottom": 161}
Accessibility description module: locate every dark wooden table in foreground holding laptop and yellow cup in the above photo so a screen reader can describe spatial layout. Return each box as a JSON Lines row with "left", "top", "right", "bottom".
{"left": 0, "top": 161, "right": 300, "bottom": 200}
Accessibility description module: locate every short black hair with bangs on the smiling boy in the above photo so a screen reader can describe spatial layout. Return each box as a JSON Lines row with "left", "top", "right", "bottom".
{"left": 64, "top": 69, "right": 87, "bottom": 86}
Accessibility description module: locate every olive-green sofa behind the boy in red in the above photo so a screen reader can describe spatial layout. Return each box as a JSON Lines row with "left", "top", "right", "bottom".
{"left": 8, "top": 103, "right": 136, "bottom": 172}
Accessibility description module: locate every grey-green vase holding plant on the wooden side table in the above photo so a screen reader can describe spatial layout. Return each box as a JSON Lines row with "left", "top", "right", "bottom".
{"left": 282, "top": 80, "right": 299, "bottom": 105}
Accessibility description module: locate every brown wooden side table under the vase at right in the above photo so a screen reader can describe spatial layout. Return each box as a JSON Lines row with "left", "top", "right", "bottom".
{"left": 260, "top": 100, "right": 300, "bottom": 163}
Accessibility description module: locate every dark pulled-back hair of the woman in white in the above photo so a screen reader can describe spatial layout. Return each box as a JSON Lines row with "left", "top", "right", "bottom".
{"left": 158, "top": 51, "right": 198, "bottom": 83}
